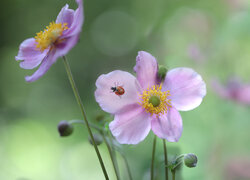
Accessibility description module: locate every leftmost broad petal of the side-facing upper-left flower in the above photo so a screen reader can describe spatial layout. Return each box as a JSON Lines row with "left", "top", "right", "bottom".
{"left": 16, "top": 38, "right": 48, "bottom": 69}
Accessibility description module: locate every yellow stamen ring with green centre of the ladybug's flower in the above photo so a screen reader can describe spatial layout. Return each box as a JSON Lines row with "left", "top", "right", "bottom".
{"left": 139, "top": 84, "right": 172, "bottom": 116}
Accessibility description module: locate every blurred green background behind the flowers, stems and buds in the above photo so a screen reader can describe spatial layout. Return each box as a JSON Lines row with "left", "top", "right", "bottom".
{"left": 0, "top": 0, "right": 250, "bottom": 180}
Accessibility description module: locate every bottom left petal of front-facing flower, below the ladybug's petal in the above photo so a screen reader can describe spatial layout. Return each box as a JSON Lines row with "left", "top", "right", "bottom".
{"left": 109, "top": 105, "right": 152, "bottom": 144}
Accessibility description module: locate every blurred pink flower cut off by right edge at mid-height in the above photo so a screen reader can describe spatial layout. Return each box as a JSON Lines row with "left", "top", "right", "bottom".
{"left": 212, "top": 78, "right": 250, "bottom": 105}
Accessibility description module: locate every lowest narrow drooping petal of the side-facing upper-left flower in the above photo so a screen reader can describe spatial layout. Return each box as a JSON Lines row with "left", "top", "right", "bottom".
{"left": 25, "top": 50, "right": 58, "bottom": 82}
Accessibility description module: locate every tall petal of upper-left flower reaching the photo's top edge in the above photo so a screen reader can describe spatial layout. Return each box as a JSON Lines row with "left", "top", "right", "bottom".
{"left": 63, "top": 0, "right": 84, "bottom": 37}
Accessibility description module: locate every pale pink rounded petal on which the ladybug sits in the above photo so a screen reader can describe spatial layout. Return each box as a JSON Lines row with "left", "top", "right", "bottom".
{"left": 95, "top": 70, "right": 139, "bottom": 114}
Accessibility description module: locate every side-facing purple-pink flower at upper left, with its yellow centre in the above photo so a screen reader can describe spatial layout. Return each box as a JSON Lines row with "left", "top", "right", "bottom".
{"left": 16, "top": 0, "right": 83, "bottom": 82}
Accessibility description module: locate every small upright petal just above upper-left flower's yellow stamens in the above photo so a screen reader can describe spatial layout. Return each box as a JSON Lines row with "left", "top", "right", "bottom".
{"left": 56, "top": 4, "right": 75, "bottom": 27}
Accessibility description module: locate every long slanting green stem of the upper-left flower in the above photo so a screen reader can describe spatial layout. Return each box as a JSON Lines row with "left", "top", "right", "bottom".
{"left": 63, "top": 56, "right": 109, "bottom": 180}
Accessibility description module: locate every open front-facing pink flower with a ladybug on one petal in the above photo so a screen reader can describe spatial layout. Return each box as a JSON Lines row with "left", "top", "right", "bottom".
{"left": 95, "top": 51, "right": 206, "bottom": 144}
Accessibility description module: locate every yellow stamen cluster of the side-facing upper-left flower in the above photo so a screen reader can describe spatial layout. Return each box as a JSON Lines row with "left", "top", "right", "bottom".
{"left": 35, "top": 22, "right": 68, "bottom": 51}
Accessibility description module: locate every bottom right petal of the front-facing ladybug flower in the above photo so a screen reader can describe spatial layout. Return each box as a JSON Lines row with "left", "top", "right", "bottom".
{"left": 151, "top": 107, "right": 182, "bottom": 142}
